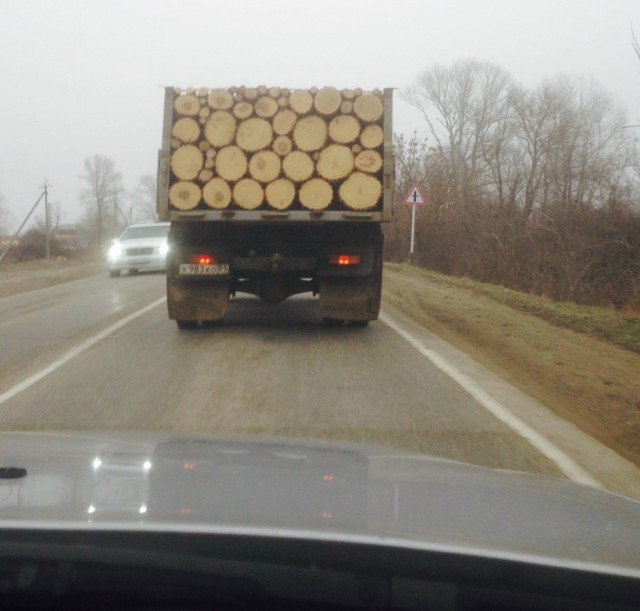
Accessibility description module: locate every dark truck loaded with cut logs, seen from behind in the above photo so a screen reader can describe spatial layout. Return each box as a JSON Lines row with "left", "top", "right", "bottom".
{"left": 157, "top": 86, "right": 393, "bottom": 328}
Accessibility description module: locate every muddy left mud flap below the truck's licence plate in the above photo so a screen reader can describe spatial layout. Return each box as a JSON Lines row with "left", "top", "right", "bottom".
{"left": 167, "top": 276, "right": 229, "bottom": 327}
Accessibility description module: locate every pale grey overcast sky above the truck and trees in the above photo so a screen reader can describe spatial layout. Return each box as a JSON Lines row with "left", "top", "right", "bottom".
{"left": 0, "top": 0, "right": 640, "bottom": 227}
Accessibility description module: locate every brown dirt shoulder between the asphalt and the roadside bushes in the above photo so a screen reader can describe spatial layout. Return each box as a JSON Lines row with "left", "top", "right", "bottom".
{"left": 383, "top": 264, "right": 640, "bottom": 466}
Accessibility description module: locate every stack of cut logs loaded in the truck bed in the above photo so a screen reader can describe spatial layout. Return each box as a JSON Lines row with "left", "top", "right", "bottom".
{"left": 169, "top": 86, "right": 383, "bottom": 211}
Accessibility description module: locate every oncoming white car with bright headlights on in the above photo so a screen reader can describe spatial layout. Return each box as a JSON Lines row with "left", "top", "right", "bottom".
{"left": 108, "top": 223, "right": 171, "bottom": 278}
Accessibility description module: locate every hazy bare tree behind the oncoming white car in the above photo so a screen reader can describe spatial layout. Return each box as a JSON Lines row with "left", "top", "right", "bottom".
{"left": 80, "top": 155, "right": 123, "bottom": 249}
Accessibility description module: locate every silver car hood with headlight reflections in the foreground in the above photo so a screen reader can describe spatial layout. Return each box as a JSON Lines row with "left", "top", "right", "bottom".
{"left": 0, "top": 433, "right": 640, "bottom": 576}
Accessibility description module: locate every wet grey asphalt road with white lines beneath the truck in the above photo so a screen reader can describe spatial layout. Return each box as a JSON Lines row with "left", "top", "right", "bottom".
{"left": 0, "top": 274, "right": 640, "bottom": 496}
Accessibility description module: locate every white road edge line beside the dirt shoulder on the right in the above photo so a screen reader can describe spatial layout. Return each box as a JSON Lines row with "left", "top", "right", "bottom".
{"left": 380, "top": 313, "right": 603, "bottom": 488}
